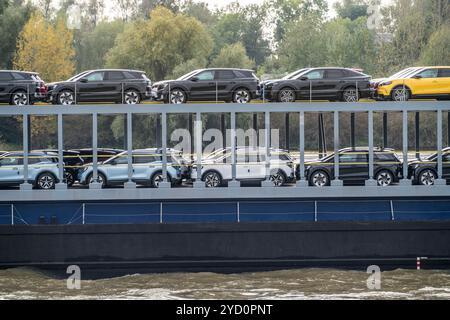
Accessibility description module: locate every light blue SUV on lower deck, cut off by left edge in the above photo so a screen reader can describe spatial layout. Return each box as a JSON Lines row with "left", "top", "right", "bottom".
{"left": 0, "top": 152, "right": 59, "bottom": 190}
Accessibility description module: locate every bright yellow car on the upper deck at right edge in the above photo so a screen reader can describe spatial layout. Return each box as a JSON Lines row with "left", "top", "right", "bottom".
{"left": 377, "top": 67, "right": 450, "bottom": 101}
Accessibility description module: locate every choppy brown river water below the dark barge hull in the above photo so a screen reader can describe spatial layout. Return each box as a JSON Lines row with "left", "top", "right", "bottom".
{"left": 0, "top": 269, "right": 450, "bottom": 300}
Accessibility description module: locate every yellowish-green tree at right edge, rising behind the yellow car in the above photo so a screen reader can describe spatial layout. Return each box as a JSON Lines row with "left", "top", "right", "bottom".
{"left": 420, "top": 25, "right": 450, "bottom": 66}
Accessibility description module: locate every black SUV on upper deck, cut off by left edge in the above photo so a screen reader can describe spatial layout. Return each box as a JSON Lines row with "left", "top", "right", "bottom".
{"left": 0, "top": 70, "right": 47, "bottom": 106}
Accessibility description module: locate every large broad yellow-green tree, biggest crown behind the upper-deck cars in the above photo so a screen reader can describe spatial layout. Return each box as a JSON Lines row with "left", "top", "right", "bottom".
{"left": 107, "top": 7, "right": 212, "bottom": 80}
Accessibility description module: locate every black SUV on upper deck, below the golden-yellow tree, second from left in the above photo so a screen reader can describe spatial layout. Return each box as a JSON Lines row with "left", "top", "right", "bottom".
{"left": 48, "top": 69, "right": 151, "bottom": 105}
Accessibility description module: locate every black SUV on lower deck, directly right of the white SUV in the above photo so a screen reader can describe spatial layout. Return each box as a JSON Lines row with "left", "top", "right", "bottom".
{"left": 297, "top": 148, "right": 403, "bottom": 187}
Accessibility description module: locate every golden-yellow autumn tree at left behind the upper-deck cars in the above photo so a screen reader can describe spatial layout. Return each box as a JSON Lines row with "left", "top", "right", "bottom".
{"left": 14, "top": 13, "right": 75, "bottom": 81}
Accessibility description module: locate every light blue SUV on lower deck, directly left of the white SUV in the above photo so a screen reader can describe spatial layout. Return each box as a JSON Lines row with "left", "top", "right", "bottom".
{"left": 79, "top": 149, "right": 186, "bottom": 188}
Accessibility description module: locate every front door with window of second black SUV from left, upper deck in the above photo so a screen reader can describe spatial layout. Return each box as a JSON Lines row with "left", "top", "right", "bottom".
{"left": 77, "top": 71, "right": 110, "bottom": 102}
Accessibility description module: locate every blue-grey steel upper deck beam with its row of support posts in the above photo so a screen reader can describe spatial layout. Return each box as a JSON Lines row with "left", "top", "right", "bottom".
{"left": 0, "top": 102, "right": 450, "bottom": 193}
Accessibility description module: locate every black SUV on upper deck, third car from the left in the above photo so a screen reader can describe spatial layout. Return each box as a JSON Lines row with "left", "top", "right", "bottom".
{"left": 152, "top": 68, "right": 259, "bottom": 104}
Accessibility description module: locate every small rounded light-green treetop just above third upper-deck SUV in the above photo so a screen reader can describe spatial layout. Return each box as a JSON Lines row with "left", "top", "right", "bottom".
{"left": 211, "top": 43, "right": 255, "bottom": 69}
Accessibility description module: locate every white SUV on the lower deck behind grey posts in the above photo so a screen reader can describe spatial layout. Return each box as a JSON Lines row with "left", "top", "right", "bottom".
{"left": 191, "top": 147, "right": 295, "bottom": 188}
